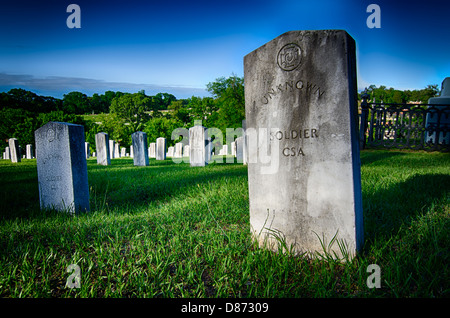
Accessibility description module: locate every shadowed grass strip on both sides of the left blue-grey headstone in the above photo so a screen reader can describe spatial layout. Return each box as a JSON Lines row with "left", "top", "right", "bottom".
{"left": 0, "top": 158, "right": 247, "bottom": 220}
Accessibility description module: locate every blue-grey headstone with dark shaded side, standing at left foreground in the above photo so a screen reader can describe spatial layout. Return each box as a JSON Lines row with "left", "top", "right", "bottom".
{"left": 34, "top": 122, "right": 89, "bottom": 214}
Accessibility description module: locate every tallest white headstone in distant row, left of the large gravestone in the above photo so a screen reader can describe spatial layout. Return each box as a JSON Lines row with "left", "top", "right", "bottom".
{"left": 189, "top": 125, "right": 209, "bottom": 167}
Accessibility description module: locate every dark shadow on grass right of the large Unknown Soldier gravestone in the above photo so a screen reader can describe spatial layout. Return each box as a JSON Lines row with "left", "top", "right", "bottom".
{"left": 363, "top": 174, "right": 450, "bottom": 243}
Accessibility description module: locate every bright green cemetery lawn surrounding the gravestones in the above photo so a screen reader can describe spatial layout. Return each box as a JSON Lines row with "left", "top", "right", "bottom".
{"left": 0, "top": 151, "right": 450, "bottom": 298}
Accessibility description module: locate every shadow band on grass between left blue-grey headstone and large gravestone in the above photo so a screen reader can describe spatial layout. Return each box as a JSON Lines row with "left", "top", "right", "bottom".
{"left": 90, "top": 161, "right": 247, "bottom": 211}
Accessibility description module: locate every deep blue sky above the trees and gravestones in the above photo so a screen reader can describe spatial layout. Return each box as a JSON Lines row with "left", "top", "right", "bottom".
{"left": 0, "top": 0, "right": 450, "bottom": 98}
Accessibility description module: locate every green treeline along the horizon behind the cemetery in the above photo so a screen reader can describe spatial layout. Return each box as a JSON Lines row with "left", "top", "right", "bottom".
{"left": 0, "top": 79, "right": 439, "bottom": 151}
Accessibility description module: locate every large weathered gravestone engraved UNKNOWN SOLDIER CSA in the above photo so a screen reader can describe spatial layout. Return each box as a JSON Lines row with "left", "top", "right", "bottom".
{"left": 244, "top": 30, "right": 363, "bottom": 257}
